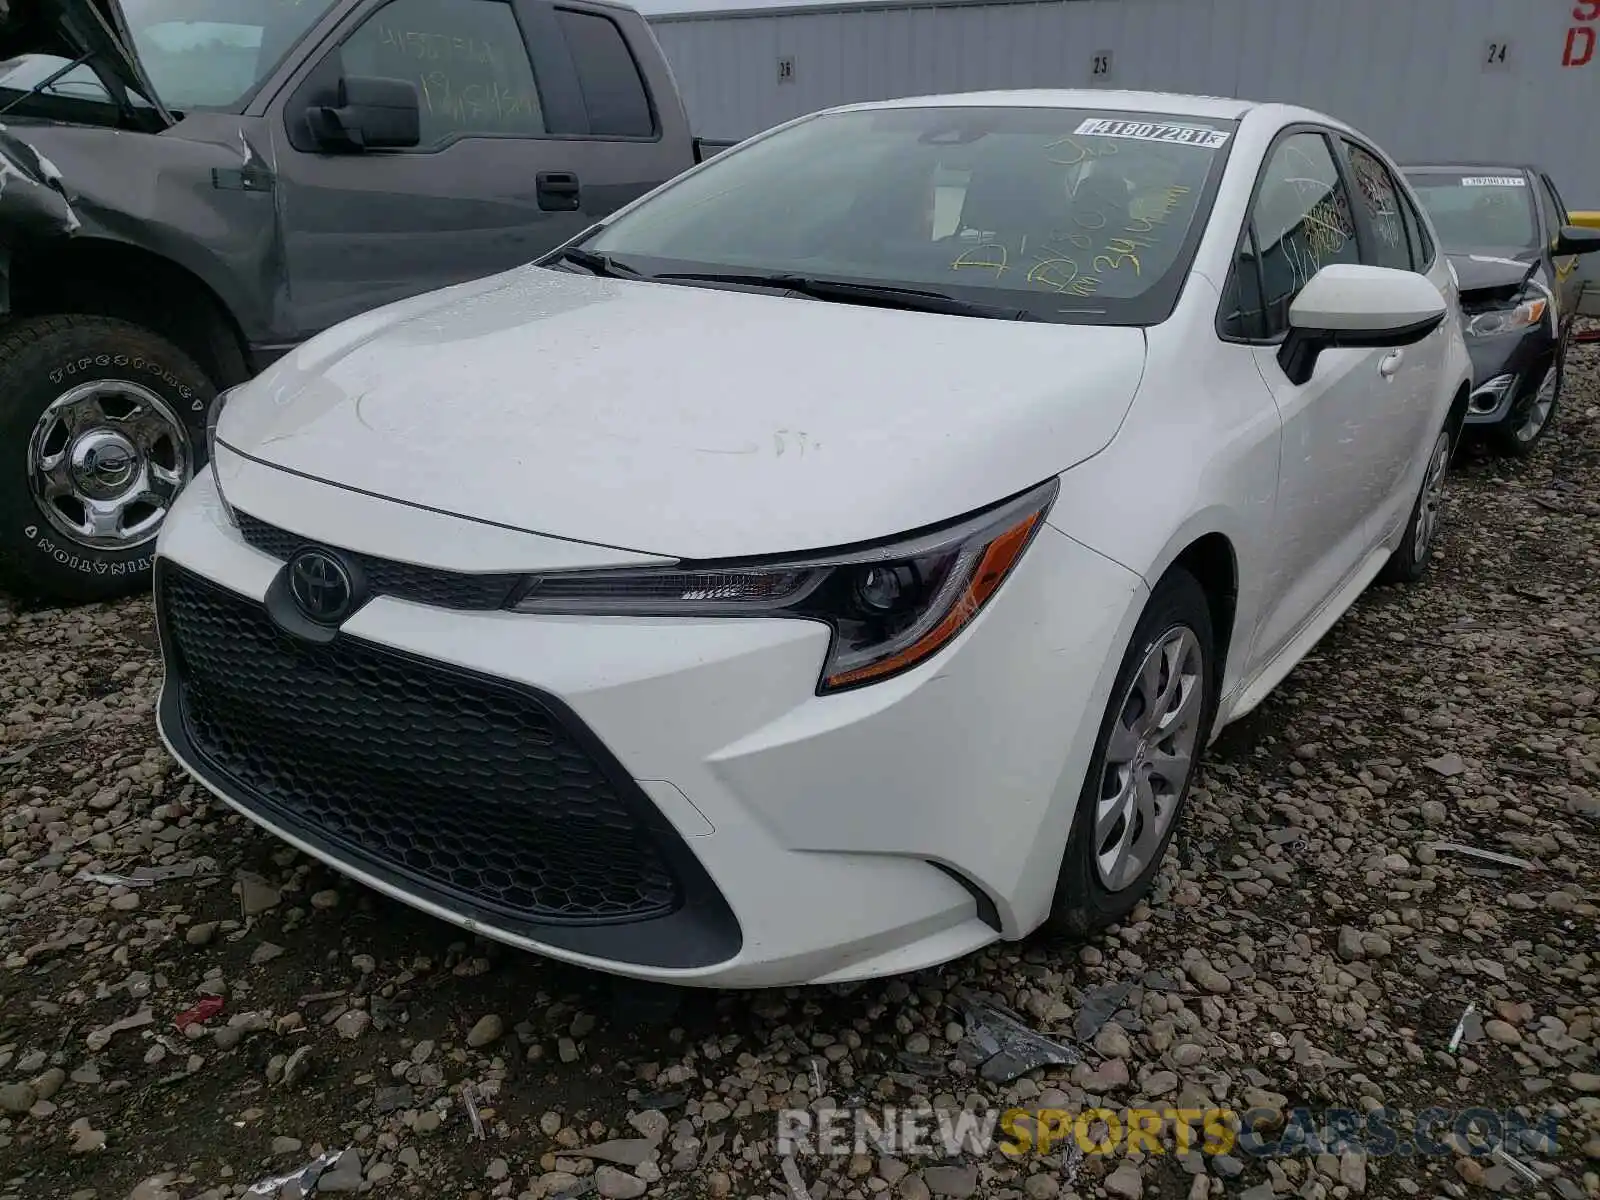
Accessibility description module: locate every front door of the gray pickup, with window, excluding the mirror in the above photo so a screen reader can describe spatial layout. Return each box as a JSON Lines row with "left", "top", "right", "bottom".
{"left": 267, "top": 0, "right": 592, "bottom": 339}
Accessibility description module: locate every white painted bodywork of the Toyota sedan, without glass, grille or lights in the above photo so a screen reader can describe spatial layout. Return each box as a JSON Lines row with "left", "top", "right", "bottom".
{"left": 158, "top": 93, "right": 1470, "bottom": 986}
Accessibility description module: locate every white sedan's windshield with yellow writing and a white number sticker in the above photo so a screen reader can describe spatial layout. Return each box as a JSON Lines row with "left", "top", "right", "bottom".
{"left": 582, "top": 107, "right": 1235, "bottom": 325}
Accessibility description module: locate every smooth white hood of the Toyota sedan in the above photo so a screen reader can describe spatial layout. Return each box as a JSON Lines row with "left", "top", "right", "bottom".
{"left": 218, "top": 267, "right": 1144, "bottom": 558}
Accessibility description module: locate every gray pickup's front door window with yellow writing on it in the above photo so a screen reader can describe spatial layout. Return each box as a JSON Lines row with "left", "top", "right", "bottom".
{"left": 341, "top": 0, "right": 546, "bottom": 149}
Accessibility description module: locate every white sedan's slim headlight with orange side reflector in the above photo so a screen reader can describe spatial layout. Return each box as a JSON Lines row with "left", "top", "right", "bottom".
{"left": 512, "top": 480, "right": 1058, "bottom": 694}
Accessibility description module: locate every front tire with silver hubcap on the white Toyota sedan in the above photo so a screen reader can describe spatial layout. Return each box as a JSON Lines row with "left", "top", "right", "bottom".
{"left": 1045, "top": 568, "right": 1219, "bottom": 938}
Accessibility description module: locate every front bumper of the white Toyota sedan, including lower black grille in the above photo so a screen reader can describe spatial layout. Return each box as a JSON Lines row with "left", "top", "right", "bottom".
{"left": 157, "top": 475, "right": 1144, "bottom": 987}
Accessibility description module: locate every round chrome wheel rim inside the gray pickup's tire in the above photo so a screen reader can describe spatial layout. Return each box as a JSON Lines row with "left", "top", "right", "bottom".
{"left": 27, "top": 379, "right": 194, "bottom": 550}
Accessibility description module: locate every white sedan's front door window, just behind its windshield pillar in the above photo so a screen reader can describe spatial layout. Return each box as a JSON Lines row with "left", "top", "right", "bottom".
{"left": 1222, "top": 133, "right": 1360, "bottom": 339}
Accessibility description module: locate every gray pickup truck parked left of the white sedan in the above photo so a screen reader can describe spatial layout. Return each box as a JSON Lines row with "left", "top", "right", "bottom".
{"left": 0, "top": 0, "right": 720, "bottom": 602}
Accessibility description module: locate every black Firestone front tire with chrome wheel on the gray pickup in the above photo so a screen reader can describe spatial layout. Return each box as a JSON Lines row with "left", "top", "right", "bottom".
{"left": 0, "top": 315, "right": 216, "bottom": 603}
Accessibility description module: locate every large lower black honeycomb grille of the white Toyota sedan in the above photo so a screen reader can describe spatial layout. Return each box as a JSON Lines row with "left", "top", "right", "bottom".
{"left": 157, "top": 563, "right": 682, "bottom": 923}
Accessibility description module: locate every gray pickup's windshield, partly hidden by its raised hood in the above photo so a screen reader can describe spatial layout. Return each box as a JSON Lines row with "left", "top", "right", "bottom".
{"left": 0, "top": 0, "right": 331, "bottom": 112}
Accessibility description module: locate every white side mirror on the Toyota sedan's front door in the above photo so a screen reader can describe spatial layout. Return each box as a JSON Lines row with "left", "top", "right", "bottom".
{"left": 1278, "top": 262, "right": 1450, "bottom": 384}
